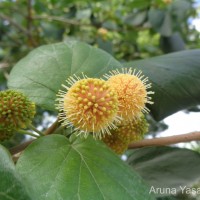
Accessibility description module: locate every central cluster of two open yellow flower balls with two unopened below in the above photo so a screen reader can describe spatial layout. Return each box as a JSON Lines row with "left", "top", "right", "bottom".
{"left": 56, "top": 68, "right": 153, "bottom": 153}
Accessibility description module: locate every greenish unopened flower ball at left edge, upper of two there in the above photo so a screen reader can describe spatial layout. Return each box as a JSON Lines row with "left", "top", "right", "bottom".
{"left": 0, "top": 90, "right": 35, "bottom": 132}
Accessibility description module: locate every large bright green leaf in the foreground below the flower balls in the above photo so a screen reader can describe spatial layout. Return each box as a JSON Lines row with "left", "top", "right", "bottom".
{"left": 17, "top": 135, "right": 154, "bottom": 200}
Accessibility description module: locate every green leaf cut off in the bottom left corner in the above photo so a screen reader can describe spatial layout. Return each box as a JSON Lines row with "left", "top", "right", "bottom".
{"left": 0, "top": 145, "right": 31, "bottom": 200}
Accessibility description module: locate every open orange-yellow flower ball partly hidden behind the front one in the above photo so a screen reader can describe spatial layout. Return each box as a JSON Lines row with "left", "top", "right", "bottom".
{"left": 105, "top": 69, "right": 154, "bottom": 120}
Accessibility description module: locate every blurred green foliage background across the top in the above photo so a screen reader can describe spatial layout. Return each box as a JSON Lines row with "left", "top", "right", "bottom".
{"left": 0, "top": 0, "right": 199, "bottom": 69}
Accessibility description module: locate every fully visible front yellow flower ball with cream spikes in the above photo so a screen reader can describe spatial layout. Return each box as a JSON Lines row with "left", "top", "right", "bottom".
{"left": 57, "top": 76, "right": 118, "bottom": 138}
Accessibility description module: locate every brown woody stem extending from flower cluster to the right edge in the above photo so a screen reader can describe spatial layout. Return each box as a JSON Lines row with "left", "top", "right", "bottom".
{"left": 129, "top": 132, "right": 200, "bottom": 149}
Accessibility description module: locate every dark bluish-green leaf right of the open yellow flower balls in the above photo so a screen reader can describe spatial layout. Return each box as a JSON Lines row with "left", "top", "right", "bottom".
{"left": 124, "top": 50, "right": 200, "bottom": 120}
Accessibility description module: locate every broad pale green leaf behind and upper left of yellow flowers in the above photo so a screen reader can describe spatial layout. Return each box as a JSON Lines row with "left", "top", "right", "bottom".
{"left": 8, "top": 41, "right": 121, "bottom": 110}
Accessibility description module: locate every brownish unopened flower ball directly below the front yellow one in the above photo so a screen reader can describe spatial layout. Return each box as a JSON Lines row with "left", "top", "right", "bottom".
{"left": 102, "top": 130, "right": 129, "bottom": 155}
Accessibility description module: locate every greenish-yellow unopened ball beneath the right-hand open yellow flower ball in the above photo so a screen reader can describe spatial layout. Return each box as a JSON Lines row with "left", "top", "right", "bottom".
{"left": 113, "top": 114, "right": 149, "bottom": 143}
